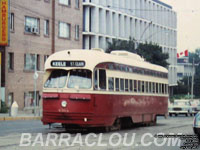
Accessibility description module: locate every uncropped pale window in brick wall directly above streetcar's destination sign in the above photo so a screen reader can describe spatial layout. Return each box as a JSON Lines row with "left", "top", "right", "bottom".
{"left": 58, "top": 22, "right": 71, "bottom": 38}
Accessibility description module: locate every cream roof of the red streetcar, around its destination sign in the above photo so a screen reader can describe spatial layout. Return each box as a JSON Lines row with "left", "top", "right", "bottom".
{"left": 45, "top": 49, "right": 168, "bottom": 73}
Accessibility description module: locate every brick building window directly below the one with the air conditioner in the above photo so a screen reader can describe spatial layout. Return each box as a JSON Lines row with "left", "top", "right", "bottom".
{"left": 24, "top": 54, "right": 40, "bottom": 71}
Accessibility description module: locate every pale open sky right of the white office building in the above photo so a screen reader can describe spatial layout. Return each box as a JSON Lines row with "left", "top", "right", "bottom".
{"left": 160, "top": 0, "right": 200, "bottom": 52}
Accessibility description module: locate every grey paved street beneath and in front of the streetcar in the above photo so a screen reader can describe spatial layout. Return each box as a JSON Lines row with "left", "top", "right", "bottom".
{"left": 0, "top": 116, "right": 198, "bottom": 150}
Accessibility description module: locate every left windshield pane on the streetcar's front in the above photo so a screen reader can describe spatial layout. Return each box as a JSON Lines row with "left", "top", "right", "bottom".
{"left": 44, "top": 70, "right": 68, "bottom": 88}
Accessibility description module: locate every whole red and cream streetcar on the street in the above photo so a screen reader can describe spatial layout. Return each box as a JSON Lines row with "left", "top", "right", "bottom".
{"left": 42, "top": 49, "right": 168, "bottom": 128}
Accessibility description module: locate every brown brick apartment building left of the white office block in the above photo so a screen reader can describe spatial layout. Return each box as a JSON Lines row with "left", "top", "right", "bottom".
{"left": 0, "top": 0, "right": 82, "bottom": 109}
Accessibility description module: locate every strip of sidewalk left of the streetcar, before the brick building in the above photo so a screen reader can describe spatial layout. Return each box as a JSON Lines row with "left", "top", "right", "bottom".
{"left": 0, "top": 111, "right": 42, "bottom": 121}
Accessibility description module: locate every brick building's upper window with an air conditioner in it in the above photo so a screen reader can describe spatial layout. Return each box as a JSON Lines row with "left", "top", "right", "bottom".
{"left": 25, "top": 17, "right": 40, "bottom": 34}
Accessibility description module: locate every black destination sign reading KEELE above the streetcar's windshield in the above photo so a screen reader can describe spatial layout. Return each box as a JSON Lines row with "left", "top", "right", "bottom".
{"left": 51, "top": 61, "right": 85, "bottom": 67}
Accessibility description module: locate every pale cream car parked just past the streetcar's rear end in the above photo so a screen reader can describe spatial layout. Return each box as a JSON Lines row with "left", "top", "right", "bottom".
{"left": 168, "top": 100, "right": 196, "bottom": 116}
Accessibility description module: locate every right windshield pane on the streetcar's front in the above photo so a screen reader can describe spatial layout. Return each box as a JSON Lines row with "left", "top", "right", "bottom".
{"left": 67, "top": 69, "right": 92, "bottom": 89}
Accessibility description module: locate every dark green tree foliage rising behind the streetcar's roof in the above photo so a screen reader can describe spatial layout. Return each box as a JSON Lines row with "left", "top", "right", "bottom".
{"left": 106, "top": 38, "right": 169, "bottom": 67}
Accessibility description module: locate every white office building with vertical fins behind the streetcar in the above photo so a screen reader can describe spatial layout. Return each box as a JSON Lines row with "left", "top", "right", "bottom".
{"left": 83, "top": 0, "right": 177, "bottom": 86}
